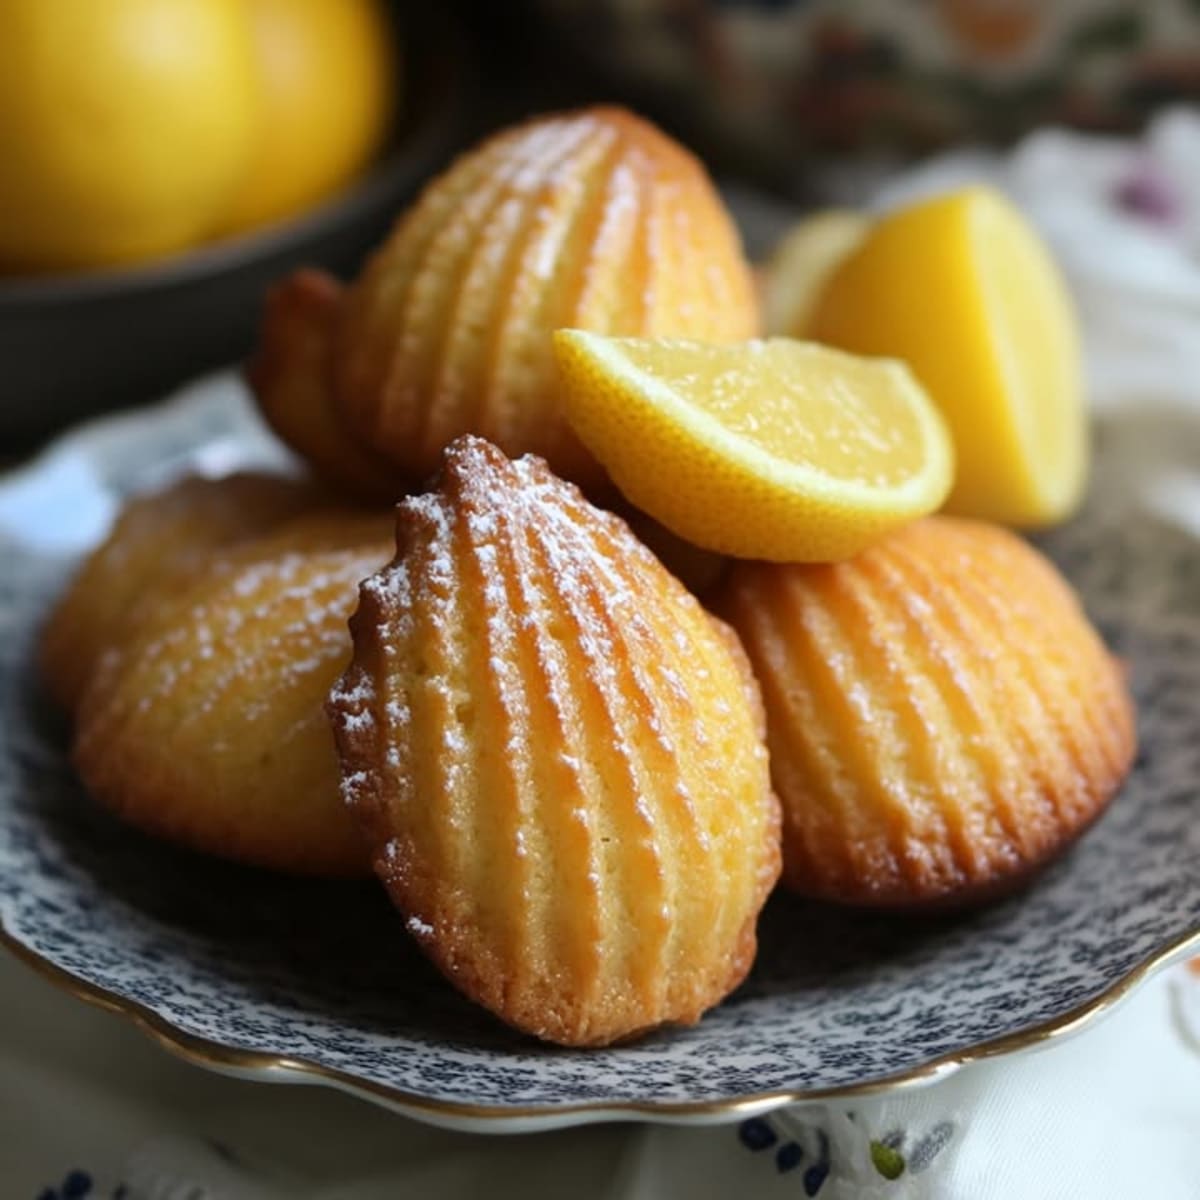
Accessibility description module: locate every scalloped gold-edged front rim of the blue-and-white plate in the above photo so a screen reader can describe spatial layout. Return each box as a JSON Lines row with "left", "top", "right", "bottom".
{"left": 0, "top": 920, "right": 1200, "bottom": 1126}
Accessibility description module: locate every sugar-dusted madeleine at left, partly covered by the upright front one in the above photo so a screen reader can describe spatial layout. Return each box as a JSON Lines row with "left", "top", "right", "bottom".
{"left": 73, "top": 511, "right": 392, "bottom": 875}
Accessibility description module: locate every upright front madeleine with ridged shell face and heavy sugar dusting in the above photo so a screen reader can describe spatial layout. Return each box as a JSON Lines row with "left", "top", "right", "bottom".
{"left": 329, "top": 437, "right": 779, "bottom": 1045}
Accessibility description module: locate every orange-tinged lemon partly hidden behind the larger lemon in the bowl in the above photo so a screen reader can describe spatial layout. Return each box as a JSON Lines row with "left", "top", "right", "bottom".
{"left": 221, "top": 0, "right": 396, "bottom": 232}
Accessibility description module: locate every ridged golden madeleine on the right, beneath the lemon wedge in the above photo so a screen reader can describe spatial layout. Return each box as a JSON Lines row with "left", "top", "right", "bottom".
{"left": 714, "top": 517, "right": 1136, "bottom": 905}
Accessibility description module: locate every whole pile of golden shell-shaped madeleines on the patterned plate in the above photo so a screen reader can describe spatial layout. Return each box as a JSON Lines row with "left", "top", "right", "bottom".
{"left": 41, "top": 108, "right": 1135, "bottom": 1045}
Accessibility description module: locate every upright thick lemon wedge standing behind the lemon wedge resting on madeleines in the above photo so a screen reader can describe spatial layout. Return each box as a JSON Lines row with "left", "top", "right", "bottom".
{"left": 805, "top": 187, "right": 1088, "bottom": 527}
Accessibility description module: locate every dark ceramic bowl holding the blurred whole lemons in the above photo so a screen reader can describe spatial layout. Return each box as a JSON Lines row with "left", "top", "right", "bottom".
{"left": 0, "top": 6, "right": 468, "bottom": 456}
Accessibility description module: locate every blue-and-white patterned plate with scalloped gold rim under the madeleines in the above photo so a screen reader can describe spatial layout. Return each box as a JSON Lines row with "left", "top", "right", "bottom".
{"left": 0, "top": 379, "right": 1200, "bottom": 1130}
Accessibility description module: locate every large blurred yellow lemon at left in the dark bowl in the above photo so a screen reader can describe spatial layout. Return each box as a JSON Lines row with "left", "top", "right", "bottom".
{"left": 0, "top": 0, "right": 262, "bottom": 271}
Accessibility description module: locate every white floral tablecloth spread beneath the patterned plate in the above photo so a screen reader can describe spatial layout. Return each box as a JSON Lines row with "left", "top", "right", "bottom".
{"left": 7, "top": 112, "right": 1200, "bottom": 1200}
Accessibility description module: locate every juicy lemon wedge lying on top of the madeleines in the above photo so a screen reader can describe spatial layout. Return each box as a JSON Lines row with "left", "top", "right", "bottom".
{"left": 554, "top": 330, "right": 954, "bottom": 562}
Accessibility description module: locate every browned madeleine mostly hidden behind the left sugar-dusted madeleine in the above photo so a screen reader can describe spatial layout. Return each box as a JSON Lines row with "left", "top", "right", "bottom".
{"left": 38, "top": 472, "right": 328, "bottom": 712}
